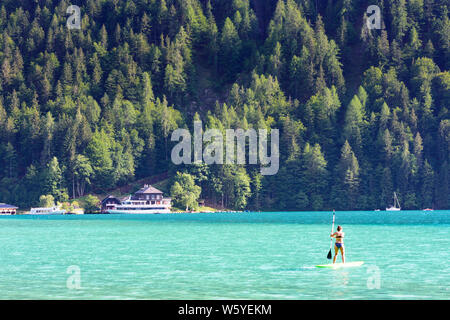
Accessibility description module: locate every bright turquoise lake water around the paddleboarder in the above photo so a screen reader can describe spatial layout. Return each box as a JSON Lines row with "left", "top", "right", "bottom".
{"left": 0, "top": 211, "right": 450, "bottom": 300}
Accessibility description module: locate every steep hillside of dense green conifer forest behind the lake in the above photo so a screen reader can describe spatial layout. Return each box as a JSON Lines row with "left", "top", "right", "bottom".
{"left": 0, "top": 0, "right": 450, "bottom": 210}
